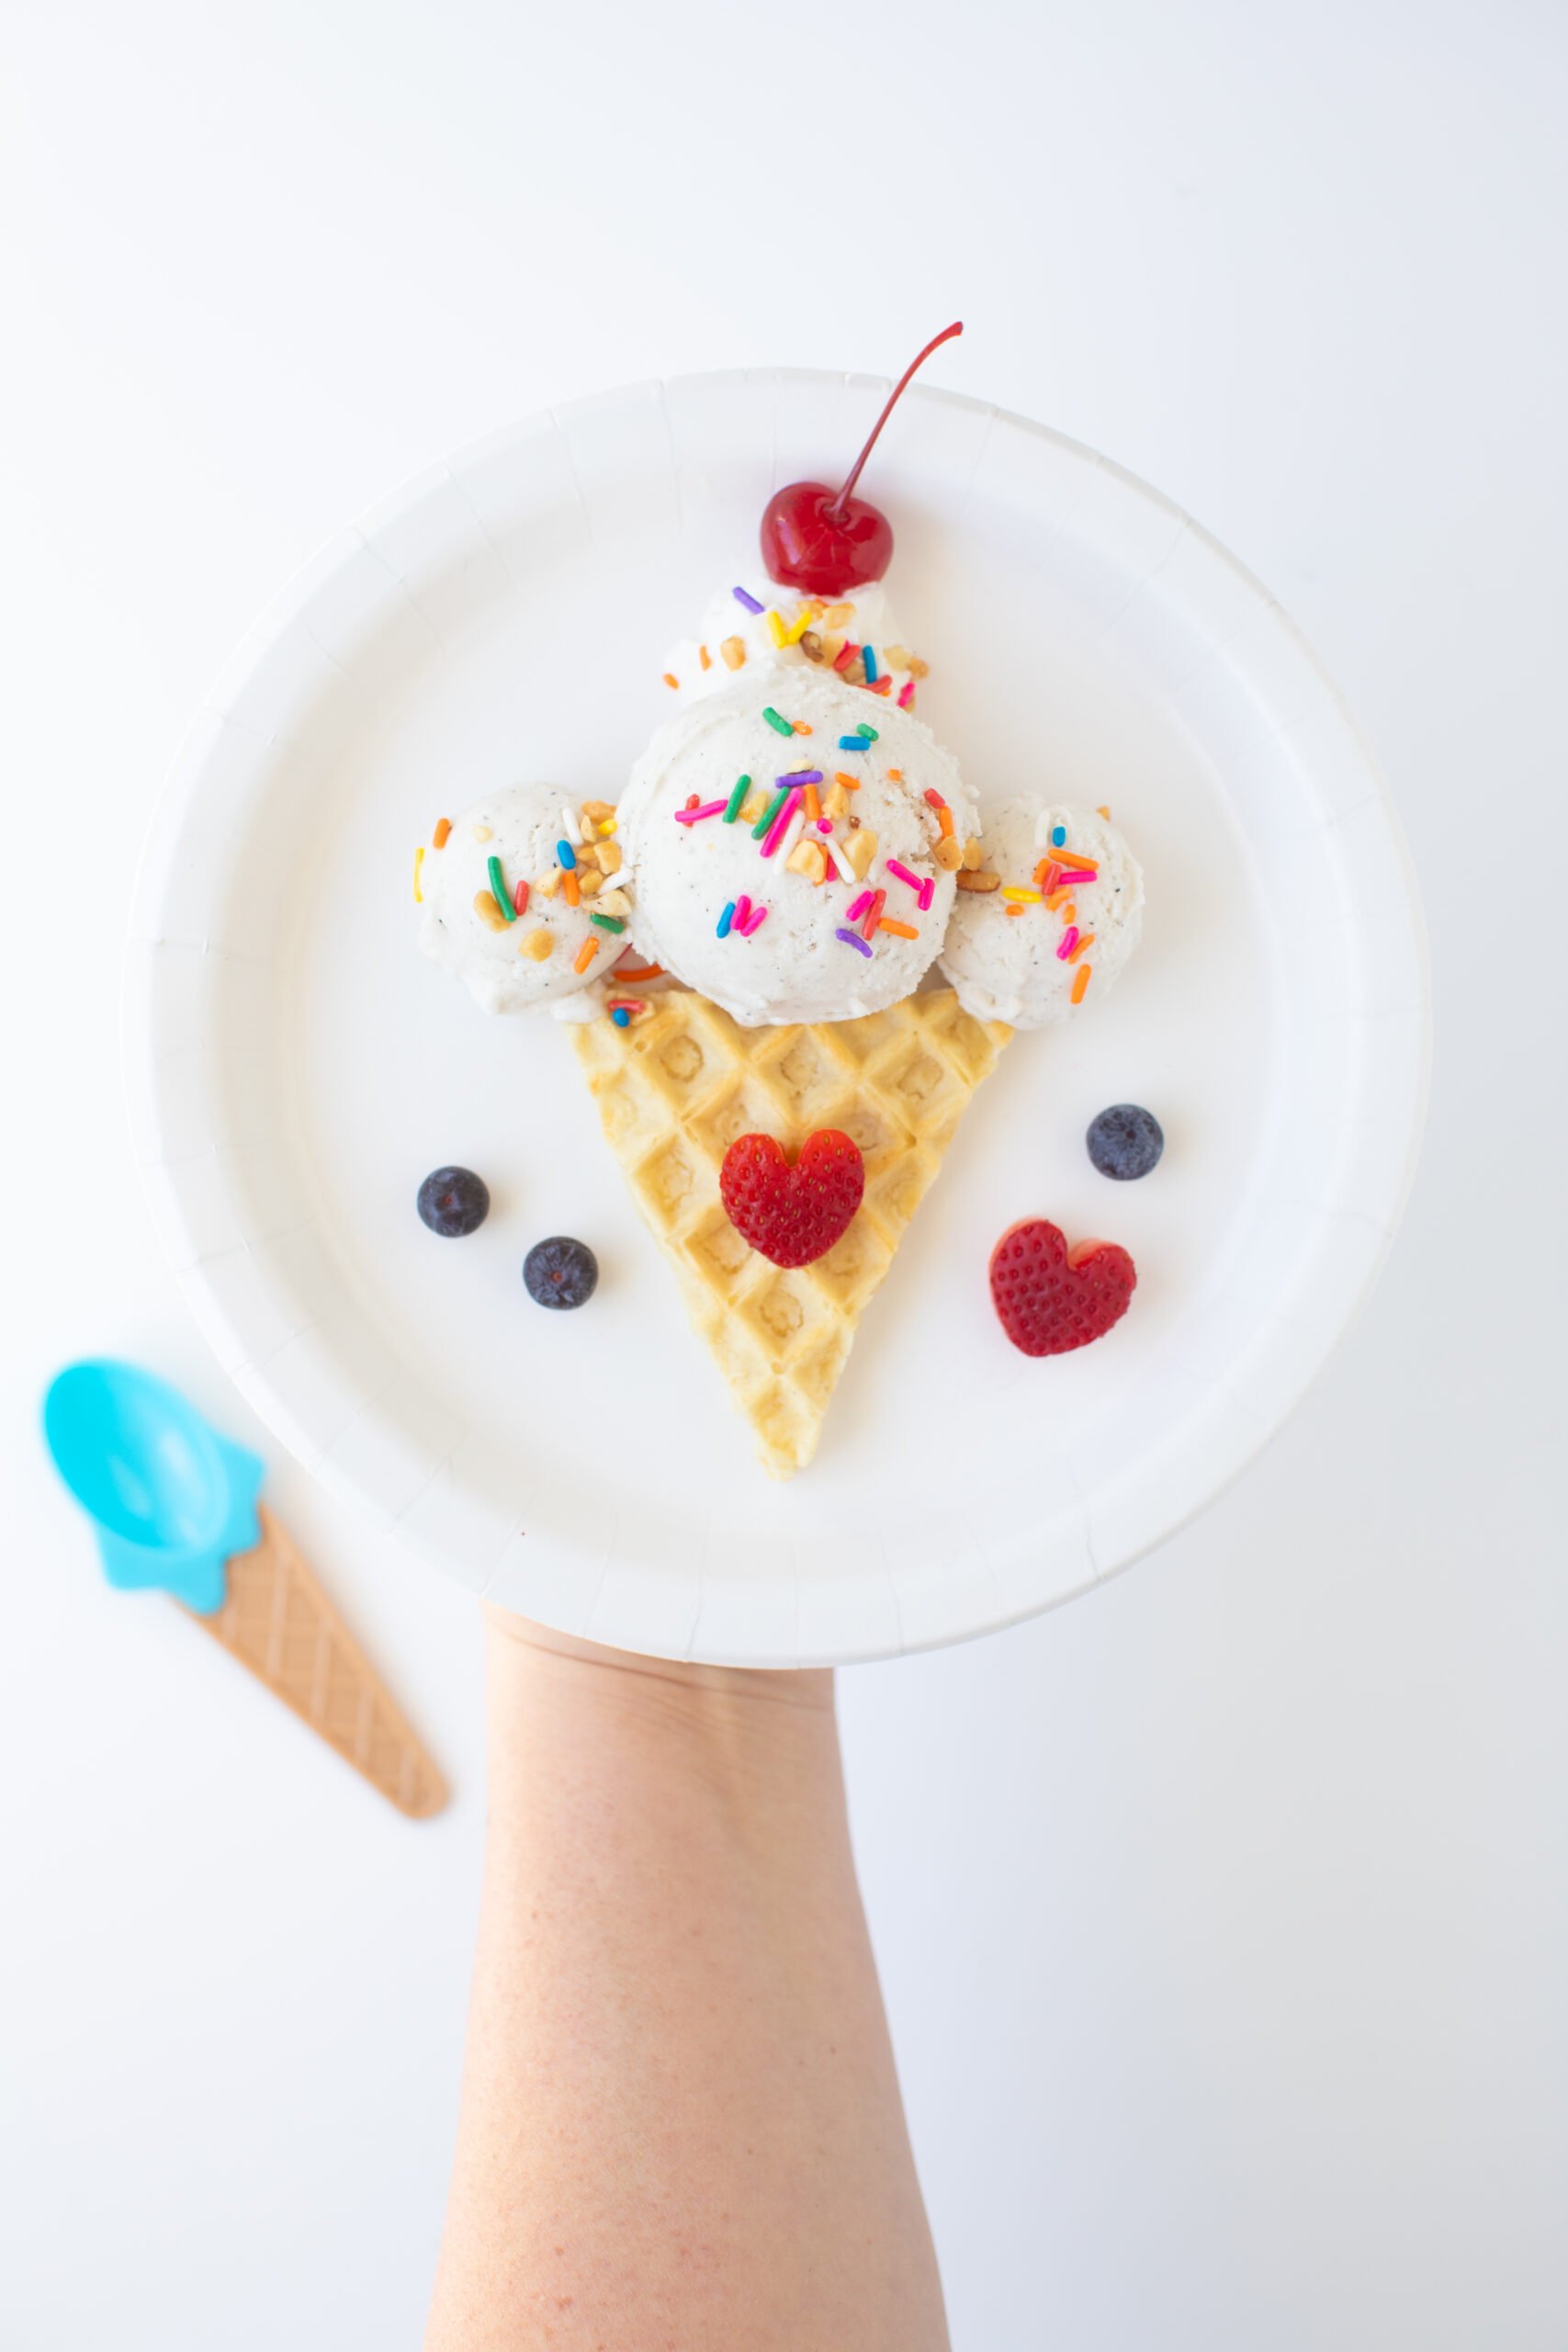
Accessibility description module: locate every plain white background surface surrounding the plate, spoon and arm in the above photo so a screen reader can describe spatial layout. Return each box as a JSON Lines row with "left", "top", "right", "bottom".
{"left": 0, "top": 0, "right": 1568, "bottom": 2352}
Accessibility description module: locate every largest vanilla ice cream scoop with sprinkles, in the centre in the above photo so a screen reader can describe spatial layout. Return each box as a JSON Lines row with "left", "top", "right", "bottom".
{"left": 618, "top": 665, "right": 976, "bottom": 1028}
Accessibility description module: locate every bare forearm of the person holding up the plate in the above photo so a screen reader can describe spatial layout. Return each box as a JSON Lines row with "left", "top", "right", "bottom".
{"left": 425, "top": 1613, "right": 947, "bottom": 2352}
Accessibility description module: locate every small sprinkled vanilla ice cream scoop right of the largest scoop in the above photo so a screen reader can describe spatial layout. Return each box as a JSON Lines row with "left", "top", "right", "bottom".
{"left": 942, "top": 795, "right": 1143, "bottom": 1028}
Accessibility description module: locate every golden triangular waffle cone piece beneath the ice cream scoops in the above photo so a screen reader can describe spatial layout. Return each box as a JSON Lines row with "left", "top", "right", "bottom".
{"left": 571, "top": 988, "right": 1013, "bottom": 1477}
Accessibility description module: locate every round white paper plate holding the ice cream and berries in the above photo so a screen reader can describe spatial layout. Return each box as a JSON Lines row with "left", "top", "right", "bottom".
{"left": 127, "top": 371, "right": 1427, "bottom": 1665}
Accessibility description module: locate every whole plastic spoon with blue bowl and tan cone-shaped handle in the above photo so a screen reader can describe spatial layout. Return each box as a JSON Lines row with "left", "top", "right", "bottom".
{"left": 45, "top": 1357, "right": 446, "bottom": 1820}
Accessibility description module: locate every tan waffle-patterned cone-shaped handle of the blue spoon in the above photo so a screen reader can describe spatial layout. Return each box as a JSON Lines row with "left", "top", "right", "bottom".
{"left": 186, "top": 1503, "right": 446, "bottom": 1820}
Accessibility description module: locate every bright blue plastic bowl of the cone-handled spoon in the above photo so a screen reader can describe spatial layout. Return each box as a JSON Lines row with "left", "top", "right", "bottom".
{"left": 45, "top": 1357, "right": 261, "bottom": 1616}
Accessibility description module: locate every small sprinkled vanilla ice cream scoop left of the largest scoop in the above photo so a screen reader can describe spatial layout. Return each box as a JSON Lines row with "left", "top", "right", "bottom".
{"left": 413, "top": 783, "right": 632, "bottom": 1021}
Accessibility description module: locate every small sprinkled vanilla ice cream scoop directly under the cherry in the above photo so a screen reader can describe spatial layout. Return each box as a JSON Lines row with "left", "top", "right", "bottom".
{"left": 665, "top": 571, "right": 926, "bottom": 703}
